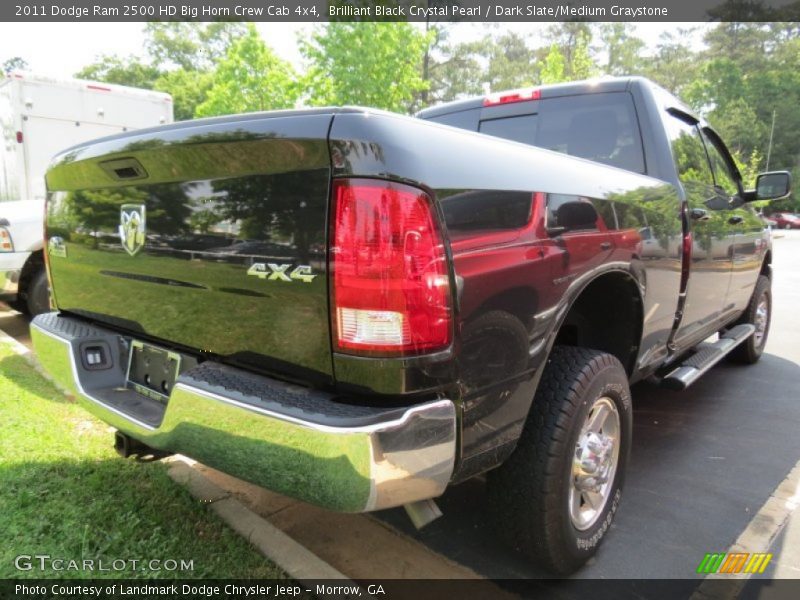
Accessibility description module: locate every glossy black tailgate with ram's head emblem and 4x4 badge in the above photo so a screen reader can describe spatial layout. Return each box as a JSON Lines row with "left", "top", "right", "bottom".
{"left": 47, "top": 111, "right": 333, "bottom": 381}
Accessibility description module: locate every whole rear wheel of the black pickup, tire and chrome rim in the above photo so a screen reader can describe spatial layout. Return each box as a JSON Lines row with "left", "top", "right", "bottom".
{"left": 487, "top": 346, "right": 632, "bottom": 575}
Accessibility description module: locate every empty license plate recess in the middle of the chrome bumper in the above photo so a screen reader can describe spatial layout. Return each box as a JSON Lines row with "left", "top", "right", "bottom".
{"left": 127, "top": 340, "right": 181, "bottom": 404}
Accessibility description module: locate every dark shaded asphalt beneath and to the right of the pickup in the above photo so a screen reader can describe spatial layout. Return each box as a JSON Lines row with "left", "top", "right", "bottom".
{"left": 379, "top": 354, "right": 800, "bottom": 591}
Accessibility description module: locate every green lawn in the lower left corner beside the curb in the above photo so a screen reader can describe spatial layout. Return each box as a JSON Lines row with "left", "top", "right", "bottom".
{"left": 0, "top": 344, "right": 284, "bottom": 578}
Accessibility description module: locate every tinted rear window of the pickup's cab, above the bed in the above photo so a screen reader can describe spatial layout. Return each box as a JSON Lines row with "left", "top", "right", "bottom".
{"left": 478, "top": 92, "right": 645, "bottom": 173}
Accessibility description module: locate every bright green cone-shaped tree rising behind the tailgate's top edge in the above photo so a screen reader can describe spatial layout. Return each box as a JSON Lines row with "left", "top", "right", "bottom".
{"left": 196, "top": 23, "right": 300, "bottom": 117}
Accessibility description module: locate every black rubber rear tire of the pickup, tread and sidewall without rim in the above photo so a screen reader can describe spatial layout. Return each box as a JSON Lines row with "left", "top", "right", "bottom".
{"left": 487, "top": 346, "right": 633, "bottom": 575}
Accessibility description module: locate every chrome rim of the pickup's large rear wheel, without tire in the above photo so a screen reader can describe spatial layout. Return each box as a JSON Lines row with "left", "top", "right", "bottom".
{"left": 568, "top": 396, "right": 621, "bottom": 531}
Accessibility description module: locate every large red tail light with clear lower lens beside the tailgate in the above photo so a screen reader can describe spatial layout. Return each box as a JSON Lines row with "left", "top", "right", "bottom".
{"left": 331, "top": 179, "right": 452, "bottom": 356}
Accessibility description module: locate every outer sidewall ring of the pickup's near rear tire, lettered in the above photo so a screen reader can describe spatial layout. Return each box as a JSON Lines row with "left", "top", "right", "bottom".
{"left": 558, "top": 367, "right": 633, "bottom": 563}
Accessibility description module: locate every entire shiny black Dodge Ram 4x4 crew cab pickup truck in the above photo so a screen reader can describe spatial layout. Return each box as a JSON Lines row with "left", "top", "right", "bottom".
{"left": 32, "top": 78, "right": 790, "bottom": 573}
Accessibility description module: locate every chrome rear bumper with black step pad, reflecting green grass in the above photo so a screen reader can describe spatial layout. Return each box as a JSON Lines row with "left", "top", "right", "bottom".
{"left": 31, "top": 313, "right": 456, "bottom": 512}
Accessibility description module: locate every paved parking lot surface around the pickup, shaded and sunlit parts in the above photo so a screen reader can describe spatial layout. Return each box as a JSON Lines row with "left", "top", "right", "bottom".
{"left": 0, "top": 231, "right": 800, "bottom": 579}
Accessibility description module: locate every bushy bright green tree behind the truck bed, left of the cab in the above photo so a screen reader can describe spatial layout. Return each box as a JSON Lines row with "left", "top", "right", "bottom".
{"left": 300, "top": 22, "right": 428, "bottom": 112}
